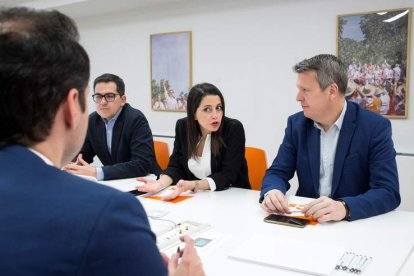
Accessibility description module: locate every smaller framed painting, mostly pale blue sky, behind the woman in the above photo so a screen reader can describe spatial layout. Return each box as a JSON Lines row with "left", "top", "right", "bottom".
{"left": 150, "top": 31, "right": 192, "bottom": 111}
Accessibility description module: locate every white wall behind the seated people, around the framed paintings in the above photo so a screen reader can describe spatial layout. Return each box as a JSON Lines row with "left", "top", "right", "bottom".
{"left": 78, "top": 0, "right": 414, "bottom": 207}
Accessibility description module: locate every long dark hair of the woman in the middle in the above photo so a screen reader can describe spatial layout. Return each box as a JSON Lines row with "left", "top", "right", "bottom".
{"left": 187, "top": 83, "right": 225, "bottom": 159}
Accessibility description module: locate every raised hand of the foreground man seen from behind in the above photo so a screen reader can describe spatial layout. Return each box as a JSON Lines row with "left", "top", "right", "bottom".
{"left": 162, "top": 236, "right": 205, "bottom": 276}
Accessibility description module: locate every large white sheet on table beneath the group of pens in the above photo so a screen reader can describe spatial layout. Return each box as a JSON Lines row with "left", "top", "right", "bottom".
{"left": 229, "top": 235, "right": 413, "bottom": 276}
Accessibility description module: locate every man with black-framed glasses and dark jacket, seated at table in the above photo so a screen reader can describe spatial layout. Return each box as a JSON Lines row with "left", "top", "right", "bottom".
{"left": 65, "top": 74, "right": 160, "bottom": 180}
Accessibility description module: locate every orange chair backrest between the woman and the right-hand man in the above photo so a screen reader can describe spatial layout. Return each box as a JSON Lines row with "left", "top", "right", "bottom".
{"left": 245, "top": 147, "right": 267, "bottom": 191}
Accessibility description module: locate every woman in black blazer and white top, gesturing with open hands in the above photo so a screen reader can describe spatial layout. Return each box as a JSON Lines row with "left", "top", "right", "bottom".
{"left": 137, "top": 83, "right": 250, "bottom": 200}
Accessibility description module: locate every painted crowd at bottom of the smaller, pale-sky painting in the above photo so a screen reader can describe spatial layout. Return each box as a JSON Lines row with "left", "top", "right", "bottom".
{"left": 151, "top": 79, "right": 188, "bottom": 111}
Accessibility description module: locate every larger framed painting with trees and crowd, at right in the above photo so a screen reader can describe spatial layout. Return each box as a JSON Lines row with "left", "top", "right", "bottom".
{"left": 337, "top": 8, "right": 412, "bottom": 119}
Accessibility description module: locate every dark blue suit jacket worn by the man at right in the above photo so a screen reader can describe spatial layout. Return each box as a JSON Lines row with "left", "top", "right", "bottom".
{"left": 260, "top": 102, "right": 401, "bottom": 220}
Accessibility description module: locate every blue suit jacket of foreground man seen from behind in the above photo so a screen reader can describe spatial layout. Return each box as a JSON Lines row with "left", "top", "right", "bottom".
{"left": 0, "top": 146, "right": 167, "bottom": 276}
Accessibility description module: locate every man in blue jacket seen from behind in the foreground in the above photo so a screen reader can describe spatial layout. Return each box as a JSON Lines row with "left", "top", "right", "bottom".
{"left": 0, "top": 8, "right": 204, "bottom": 276}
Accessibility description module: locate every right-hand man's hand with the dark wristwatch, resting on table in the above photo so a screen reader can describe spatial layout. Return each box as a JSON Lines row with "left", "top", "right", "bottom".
{"left": 303, "top": 196, "right": 346, "bottom": 222}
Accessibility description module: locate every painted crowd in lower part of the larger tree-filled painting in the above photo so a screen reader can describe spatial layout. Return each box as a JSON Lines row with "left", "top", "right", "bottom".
{"left": 345, "top": 60, "right": 407, "bottom": 116}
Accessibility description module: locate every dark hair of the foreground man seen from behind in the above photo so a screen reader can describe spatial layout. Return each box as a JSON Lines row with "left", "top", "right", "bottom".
{"left": 0, "top": 8, "right": 89, "bottom": 145}
